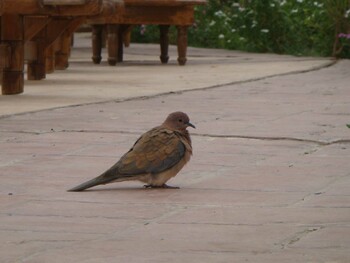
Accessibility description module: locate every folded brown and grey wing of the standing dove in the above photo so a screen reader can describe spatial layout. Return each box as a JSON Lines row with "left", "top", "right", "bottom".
{"left": 115, "top": 128, "right": 186, "bottom": 176}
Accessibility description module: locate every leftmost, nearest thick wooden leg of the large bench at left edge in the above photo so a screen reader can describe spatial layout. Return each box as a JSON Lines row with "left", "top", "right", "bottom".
{"left": 0, "top": 14, "right": 24, "bottom": 95}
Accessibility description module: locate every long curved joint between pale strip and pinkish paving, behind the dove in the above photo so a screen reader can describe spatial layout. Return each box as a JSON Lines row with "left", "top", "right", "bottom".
{"left": 0, "top": 59, "right": 338, "bottom": 120}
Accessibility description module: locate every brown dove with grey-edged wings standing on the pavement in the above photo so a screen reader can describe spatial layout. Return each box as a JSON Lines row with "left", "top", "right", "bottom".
{"left": 68, "top": 111, "right": 196, "bottom": 192}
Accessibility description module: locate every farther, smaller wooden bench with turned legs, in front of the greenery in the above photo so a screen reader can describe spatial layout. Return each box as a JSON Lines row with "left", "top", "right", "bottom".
{"left": 88, "top": 0, "right": 206, "bottom": 65}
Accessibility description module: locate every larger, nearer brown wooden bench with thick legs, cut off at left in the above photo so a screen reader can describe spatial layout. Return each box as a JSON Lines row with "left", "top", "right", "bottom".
{"left": 0, "top": 0, "right": 114, "bottom": 94}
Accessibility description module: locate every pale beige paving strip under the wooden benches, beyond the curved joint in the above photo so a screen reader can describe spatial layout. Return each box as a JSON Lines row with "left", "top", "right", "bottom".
{"left": 0, "top": 33, "right": 333, "bottom": 115}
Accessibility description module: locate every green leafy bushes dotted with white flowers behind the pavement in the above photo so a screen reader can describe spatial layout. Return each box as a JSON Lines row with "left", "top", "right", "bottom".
{"left": 131, "top": 0, "right": 350, "bottom": 58}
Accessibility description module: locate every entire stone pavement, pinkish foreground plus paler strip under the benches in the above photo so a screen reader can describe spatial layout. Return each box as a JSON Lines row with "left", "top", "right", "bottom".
{"left": 0, "top": 34, "right": 350, "bottom": 263}
